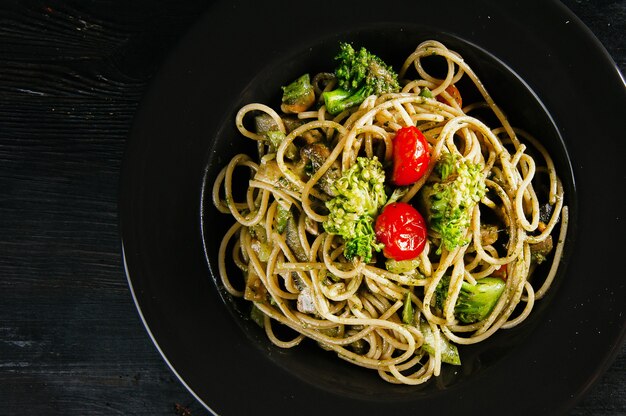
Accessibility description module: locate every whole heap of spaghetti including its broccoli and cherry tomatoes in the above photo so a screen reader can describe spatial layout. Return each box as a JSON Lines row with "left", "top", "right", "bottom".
{"left": 213, "top": 40, "right": 567, "bottom": 384}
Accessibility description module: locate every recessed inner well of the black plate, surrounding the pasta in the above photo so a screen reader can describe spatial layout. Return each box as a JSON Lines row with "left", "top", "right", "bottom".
{"left": 201, "top": 24, "right": 576, "bottom": 403}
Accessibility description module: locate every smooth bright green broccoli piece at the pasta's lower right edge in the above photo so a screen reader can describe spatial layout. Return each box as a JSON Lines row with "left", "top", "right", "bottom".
{"left": 435, "top": 277, "right": 506, "bottom": 324}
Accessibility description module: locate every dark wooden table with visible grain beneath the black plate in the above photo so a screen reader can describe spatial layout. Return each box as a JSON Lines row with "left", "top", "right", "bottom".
{"left": 0, "top": 0, "right": 626, "bottom": 416}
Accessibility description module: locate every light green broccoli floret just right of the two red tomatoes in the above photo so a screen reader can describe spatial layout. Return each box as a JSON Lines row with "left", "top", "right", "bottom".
{"left": 422, "top": 153, "right": 487, "bottom": 253}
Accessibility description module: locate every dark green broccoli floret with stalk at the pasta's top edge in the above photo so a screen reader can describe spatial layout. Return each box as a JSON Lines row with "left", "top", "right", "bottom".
{"left": 323, "top": 43, "right": 400, "bottom": 115}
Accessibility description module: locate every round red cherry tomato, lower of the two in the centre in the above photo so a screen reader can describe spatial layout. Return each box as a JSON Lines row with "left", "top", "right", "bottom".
{"left": 374, "top": 202, "right": 427, "bottom": 261}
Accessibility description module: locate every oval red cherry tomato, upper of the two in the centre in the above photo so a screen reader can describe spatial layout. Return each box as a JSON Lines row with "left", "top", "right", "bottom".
{"left": 391, "top": 126, "right": 430, "bottom": 186}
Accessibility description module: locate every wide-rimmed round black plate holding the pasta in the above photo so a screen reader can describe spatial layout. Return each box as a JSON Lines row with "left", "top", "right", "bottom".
{"left": 120, "top": 0, "right": 626, "bottom": 414}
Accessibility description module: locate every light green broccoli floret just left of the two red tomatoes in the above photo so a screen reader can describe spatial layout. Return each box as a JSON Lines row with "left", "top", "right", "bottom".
{"left": 324, "top": 157, "right": 387, "bottom": 262}
